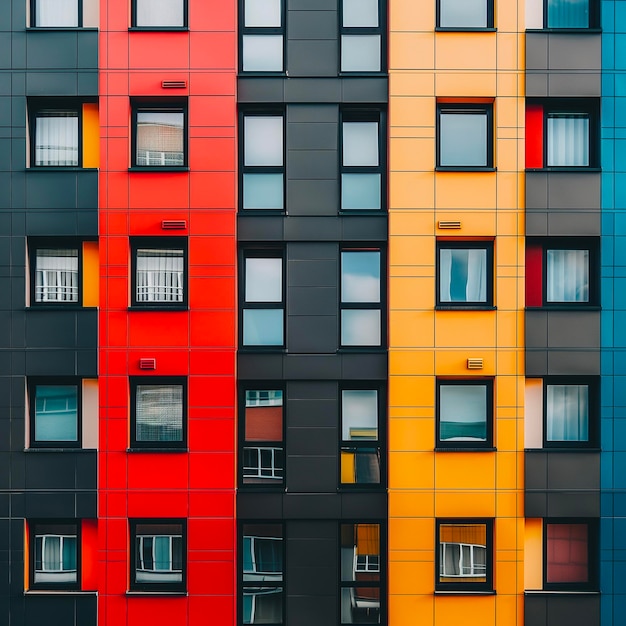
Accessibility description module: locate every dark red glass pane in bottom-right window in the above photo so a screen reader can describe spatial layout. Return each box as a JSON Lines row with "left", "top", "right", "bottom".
{"left": 546, "top": 524, "right": 590, "bottom": 584}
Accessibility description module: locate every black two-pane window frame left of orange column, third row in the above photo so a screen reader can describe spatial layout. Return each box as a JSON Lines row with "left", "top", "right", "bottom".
{"left": 338, "top": 242, "right": 388, "bottom": 352}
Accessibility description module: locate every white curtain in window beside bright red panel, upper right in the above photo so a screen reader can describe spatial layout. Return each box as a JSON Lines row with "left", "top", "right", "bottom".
{"left": 547, "top": 113, "right": 589, "bottom": 167}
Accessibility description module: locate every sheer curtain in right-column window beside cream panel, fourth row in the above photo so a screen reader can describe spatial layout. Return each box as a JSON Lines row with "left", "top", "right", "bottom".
{"left": 546, "top": 385, "right": 589, "bottom": 441}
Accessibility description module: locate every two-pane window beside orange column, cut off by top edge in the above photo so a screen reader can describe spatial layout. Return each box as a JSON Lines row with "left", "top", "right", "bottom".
{"left": 341, "top": 0, "right": 383, "bottom": 72}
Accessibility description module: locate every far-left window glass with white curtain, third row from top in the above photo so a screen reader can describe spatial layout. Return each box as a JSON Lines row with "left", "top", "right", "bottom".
{"left": 35, "top": 248, "right": 79, "bottom": 303}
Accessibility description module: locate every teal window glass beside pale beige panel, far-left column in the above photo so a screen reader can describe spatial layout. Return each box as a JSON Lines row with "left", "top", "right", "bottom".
{"left": 33, "top": 385, "right": 78, "bottom": 444}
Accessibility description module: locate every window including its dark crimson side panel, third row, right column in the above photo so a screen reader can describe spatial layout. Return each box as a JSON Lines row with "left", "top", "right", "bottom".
{"left": 526, "top": 237, "right": 599, "bottom": 308}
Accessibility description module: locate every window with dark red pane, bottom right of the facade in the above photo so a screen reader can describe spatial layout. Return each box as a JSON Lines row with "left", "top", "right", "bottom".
{"left": 544, "top": 519, "right": 598, "bottom": 591}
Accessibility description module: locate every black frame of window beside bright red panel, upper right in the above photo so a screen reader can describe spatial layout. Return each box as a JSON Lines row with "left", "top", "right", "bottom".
{"left": 540, "top": 98, "right": 601, "bottom": 172}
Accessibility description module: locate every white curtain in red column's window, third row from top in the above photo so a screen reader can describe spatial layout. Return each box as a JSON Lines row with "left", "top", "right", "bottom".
{"left": 136, "top": 249, "right": 184, "bottom": 302}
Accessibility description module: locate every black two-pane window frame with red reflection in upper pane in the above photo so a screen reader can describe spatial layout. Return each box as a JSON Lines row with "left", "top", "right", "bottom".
{"left": 238, "top": 381, "right": 287, "bottom": 491}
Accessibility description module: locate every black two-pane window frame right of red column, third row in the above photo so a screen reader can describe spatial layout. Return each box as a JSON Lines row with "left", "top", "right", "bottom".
{"left": 239, "top": 247, "right": 287, "bottom": 352}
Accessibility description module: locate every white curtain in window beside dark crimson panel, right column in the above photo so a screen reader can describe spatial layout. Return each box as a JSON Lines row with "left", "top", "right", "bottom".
{"left": 547, "top": 250, "right": 589, "bottom": 302}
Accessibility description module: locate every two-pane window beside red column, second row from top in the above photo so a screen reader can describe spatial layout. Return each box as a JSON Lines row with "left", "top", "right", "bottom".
{"left": 240, "top": 113, "right": 285, "bottom": 211}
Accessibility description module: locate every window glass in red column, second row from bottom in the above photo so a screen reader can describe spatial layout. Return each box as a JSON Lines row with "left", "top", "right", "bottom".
{"left": 135, "top": 384, "right": 184, "bottom": 444}
